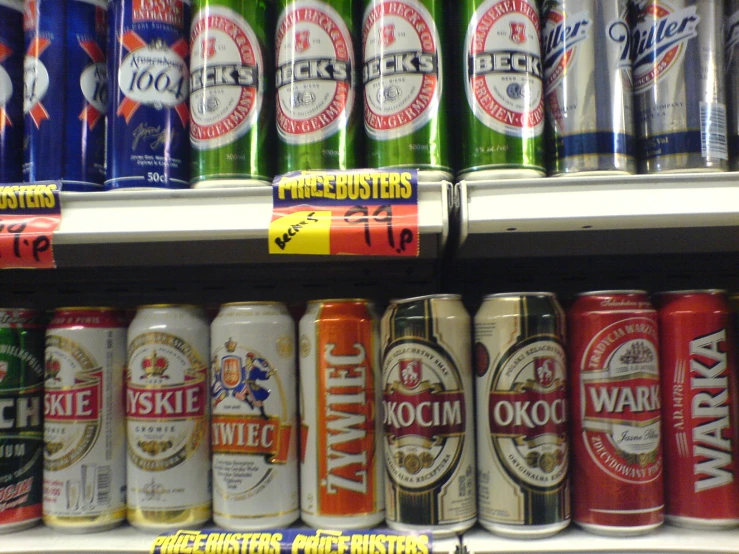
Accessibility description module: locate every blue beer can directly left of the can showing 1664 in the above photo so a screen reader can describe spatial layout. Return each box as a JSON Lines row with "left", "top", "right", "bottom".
{"left": 23, "top": 0, "right": 107, "bottom": 191}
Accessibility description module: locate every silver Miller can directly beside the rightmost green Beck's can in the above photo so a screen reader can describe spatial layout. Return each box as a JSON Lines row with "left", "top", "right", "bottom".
{"left": 542, "top": 0, "right": 636, "bottom": 175}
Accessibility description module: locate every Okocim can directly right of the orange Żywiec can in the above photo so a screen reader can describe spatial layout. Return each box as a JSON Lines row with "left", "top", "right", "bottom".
{"left": 382, "top": 294, "right": 477, "bottom": 537}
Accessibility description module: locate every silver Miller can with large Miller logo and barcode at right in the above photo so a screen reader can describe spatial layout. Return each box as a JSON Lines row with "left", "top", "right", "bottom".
{"left": 632, "top": 0, "right": 728, "bottom": 173}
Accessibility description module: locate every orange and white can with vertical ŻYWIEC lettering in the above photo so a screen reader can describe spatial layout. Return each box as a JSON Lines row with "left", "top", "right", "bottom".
{"left": 298, "top": 299, "right": 385, "bottom": 529}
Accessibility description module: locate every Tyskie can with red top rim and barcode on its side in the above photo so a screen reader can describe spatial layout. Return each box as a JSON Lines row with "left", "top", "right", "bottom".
{"left": 43, "top": 307, "right": 126, "bottom": 533}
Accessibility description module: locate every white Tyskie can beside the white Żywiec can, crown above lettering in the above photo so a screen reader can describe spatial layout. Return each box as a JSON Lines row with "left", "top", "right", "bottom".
{"left": 125, "top": 304, "right": 211, "bottom": 531}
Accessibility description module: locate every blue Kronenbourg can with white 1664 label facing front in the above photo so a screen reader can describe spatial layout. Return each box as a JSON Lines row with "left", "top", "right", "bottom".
{"left": 105, "top": 0, "right": 190, "bottom": 190}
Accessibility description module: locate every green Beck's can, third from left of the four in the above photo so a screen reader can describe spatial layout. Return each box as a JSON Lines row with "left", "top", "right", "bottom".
{"left": 362, "top": 0, "right": 452, "bottom": 180}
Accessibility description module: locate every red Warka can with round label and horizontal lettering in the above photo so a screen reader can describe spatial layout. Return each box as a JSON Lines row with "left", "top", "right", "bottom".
{"left": 568, "top": 290, "right": 664, "bottom": 536}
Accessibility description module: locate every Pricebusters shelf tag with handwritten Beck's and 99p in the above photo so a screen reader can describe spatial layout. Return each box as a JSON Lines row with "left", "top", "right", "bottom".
{"left": 269, "top": 170, "right": 419, "bottom": 256}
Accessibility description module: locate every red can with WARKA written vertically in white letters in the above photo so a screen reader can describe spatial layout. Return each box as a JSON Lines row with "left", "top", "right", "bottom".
{"left": 657, "top": 290, "right": 739, "bottom": 529}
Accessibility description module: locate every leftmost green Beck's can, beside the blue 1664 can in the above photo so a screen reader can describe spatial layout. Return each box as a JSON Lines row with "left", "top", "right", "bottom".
{"left": 190, "top": 0, "right": 275, "bottom": 187}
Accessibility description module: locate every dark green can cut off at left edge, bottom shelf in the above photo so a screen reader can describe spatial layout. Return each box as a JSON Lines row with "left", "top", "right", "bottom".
{"left": 0, "top": 309, "right": 44, "bottom": 533}
